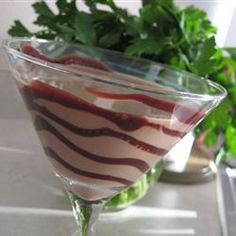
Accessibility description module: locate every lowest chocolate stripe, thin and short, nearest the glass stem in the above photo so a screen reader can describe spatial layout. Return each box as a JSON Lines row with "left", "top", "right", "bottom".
{"left": 44, "top": 147, "right": 133, "bottom": 186}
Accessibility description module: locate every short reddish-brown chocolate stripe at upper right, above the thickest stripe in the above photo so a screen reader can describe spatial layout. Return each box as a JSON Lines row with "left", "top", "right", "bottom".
{"left": 86, "top": 87, "right": 204, "bottom": 125}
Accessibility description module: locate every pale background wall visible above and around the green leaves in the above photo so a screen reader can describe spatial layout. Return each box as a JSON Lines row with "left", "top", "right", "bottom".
{"left": 0, "top": 0, "right": 236, "bottom": 69}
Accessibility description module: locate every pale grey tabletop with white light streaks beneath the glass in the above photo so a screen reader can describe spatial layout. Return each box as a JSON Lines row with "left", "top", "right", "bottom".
{"left": 0, "top": 71, "right": 221, "bottom": 236}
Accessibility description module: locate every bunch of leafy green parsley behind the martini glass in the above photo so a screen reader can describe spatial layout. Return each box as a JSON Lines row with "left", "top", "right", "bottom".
{"left": 9, "top": 0, "right": 236, "bottom": 159}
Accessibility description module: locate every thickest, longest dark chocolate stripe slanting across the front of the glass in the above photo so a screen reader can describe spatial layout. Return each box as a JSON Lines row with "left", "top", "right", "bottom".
{"left": 21, "top": 81, "right": 186, "bottom": 137}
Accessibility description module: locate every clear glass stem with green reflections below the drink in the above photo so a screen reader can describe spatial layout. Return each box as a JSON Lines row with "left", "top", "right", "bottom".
{"left": 67, "top": 192, "right": 104, "bottom": 236}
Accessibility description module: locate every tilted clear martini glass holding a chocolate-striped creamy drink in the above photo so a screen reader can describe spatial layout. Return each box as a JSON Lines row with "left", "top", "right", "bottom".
{"left": 4, "top": 38, "right": 226, "bottom": 236}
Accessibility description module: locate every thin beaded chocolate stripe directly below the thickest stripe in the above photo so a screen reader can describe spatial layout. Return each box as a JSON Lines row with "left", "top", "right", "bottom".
{"left": 34, "top": 111, "right": 167, "bottom": 156}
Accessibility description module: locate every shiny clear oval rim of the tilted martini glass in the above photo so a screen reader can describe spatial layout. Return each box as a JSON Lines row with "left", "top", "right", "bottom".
{"left": 2, "top": 37, "right": 227, "bottom": 100}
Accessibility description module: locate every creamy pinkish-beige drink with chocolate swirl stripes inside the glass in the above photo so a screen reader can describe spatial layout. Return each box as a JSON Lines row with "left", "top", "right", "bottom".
{"left": 17, "top": 45, "right": 204, "bottom": 201}
